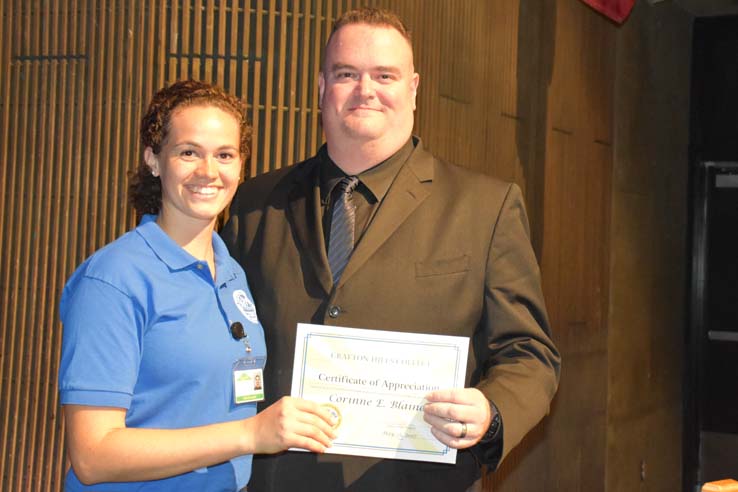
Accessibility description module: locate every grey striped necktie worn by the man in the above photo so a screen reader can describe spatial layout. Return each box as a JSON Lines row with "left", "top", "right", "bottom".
{"left": 328, "top": 176, "right": 359, "bottom": 285}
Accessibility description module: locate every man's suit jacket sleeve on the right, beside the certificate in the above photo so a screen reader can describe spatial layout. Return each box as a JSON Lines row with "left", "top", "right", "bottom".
{"left": 472, "top": 184, "right": 561, "bottom": 468}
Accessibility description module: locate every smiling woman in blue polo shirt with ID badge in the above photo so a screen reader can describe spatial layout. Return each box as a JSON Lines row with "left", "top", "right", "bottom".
{"left": 59, "top": 81, "right": 335, "bottom": 491}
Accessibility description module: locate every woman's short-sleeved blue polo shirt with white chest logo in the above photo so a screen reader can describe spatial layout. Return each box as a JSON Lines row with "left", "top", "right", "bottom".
{"left": 59, "top": 215, "right": 266, "bottom": 491}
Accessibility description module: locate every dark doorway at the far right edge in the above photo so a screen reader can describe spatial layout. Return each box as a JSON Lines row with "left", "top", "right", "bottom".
{"left": 684, "top": 16, "right": 738, "bottom": 492}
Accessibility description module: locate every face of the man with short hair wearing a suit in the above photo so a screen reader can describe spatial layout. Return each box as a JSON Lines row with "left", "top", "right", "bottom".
{"left": 318, "top": 24, "right": 419, "bottom": 146}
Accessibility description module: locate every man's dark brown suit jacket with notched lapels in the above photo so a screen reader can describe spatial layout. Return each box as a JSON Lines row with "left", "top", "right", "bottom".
{"left": 223, "top": 140, "right": 560, "bottom": 492}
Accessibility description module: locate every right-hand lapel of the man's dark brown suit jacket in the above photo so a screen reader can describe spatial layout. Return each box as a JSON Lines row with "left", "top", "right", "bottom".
{"left": 338, "top": 143, "right": 433, "bottom": 286}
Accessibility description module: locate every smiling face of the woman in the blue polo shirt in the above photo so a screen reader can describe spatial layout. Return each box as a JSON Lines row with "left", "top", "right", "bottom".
{"left": 145, "top": 106, "right": 241, "bottom": 226}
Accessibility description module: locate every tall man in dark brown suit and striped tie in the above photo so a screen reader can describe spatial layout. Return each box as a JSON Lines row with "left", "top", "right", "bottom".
{"left": 223, "top": 9, "right": 560, "bottom": 492}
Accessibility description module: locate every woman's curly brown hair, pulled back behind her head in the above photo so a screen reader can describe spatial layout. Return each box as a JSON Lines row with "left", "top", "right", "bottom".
{"left": 128, "top": 80, "right": 251, "bottom": 216}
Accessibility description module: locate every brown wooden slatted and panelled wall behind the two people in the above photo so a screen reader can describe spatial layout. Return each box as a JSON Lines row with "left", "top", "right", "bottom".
{"left": 0, "top": 0, "right": 680, "bottom": 492}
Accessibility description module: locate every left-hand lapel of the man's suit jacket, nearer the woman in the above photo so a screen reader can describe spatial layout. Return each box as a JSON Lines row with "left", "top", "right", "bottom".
{"left": 287, "top": 160, "right": 333, "bottom": 293}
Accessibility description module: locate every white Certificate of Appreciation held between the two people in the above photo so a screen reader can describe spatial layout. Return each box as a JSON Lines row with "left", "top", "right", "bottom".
{"left": 292, "top": 324, "right": 469, "bottom": 463}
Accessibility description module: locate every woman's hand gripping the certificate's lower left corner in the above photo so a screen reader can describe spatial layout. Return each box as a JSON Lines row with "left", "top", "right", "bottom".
{"left": 248, "top": 396, "right": 336, "bottom": 454}
